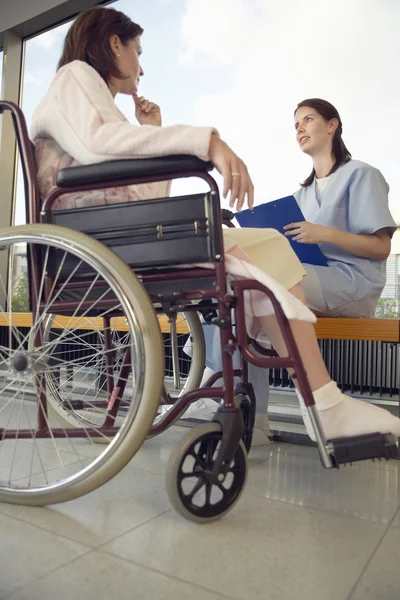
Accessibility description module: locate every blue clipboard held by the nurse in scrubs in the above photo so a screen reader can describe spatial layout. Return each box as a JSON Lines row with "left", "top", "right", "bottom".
{"left": 235, "top": 196, "right": 328, "bottom": 267}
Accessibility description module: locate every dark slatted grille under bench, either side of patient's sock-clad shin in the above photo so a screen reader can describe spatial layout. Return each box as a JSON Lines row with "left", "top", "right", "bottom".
{"left": 269, "top": 340, "right": 400, "bottom": 398}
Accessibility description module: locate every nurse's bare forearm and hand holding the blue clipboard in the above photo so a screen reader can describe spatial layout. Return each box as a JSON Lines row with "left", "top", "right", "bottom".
{"left": 284, "top": 221, "right": 391, "bottom": 260}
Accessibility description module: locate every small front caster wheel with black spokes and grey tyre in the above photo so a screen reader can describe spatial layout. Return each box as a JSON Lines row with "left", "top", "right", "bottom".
{"left": 166, "top": 423, "right": 247, "bottom": 523}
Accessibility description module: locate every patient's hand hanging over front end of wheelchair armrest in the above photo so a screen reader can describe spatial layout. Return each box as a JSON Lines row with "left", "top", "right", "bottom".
{"left": 208, "top": 134, "right": 254, "bottom": 211}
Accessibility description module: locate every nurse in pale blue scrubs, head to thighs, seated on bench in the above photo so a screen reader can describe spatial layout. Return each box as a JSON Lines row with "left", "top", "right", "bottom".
{"left": 285, "top": 98, "right": 396, "bottom": 318}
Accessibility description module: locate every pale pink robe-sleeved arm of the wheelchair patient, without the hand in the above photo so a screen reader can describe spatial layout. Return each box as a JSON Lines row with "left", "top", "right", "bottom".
{"left": 31, "top": 61, "right": 216, "bottom": 164}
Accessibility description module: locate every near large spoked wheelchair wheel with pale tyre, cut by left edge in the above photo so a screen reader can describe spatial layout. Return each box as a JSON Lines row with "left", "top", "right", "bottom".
{"left": 0, "top": 225, "right": 164, "bottom": 505}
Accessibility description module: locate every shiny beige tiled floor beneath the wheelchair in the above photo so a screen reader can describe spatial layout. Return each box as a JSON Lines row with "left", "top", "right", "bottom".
{"left": 0, "top": 427, "right": 400, "bottom": 600}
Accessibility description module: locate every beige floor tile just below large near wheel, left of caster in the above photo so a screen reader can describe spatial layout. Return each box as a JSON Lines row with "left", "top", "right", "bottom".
{"left": 0, "top": 468, "right": 171, "bottom": 547}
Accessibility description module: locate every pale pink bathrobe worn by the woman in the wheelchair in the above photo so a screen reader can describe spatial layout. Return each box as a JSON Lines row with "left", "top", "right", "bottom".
{"left": 30, "top": 61, "right": 315, "bottom": 341}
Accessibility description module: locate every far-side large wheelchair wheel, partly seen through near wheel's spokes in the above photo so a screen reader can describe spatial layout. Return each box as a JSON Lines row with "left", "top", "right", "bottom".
{"left": 43, "top": 311, "right": 205, "bottom": 436}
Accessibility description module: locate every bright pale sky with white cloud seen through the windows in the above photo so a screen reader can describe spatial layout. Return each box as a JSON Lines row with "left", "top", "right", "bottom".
{"left": 5, "top": 0, "right": 400, "bottom": 234}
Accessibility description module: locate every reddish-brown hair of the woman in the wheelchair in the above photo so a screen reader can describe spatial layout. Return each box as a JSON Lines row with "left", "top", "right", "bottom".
{"left": 57, "top": 7, "right": 143, "bottom": 84}
